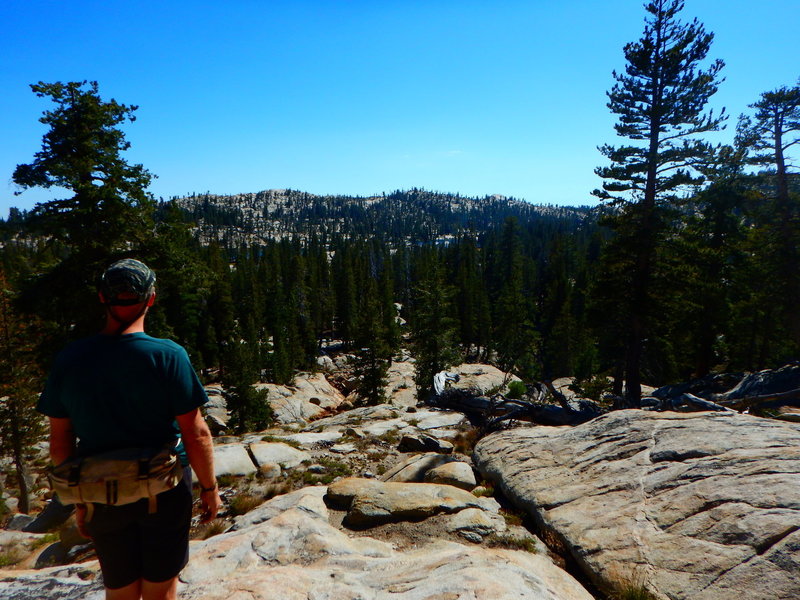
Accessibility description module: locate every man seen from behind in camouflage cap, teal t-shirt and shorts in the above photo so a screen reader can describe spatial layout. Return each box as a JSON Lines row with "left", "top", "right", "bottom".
{"left": 38, "top": 259, "right": 221, "bottom": 600}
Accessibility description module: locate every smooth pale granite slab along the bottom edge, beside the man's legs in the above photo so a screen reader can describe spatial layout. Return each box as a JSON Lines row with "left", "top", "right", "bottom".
{"left": 0, "top": 484, "right": 592, "bottom": 600}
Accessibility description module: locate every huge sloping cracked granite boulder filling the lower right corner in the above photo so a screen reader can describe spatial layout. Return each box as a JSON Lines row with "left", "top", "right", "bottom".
{"left": 474, "top": 410, "right": 800, "bottom": 600}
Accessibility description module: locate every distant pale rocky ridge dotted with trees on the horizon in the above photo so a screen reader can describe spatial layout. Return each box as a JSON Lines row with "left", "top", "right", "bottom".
{"left": 174, "top": 188, "right": 591, "bottom": 245}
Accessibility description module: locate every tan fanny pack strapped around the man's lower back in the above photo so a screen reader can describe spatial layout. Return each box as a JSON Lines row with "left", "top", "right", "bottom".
{"left": 49, "top": 441, "right": 183, "bottom": 513}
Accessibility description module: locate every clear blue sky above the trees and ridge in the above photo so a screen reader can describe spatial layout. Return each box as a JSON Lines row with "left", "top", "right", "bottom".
{"left": 0, "top": 0, "right": 800, "bottom": 216}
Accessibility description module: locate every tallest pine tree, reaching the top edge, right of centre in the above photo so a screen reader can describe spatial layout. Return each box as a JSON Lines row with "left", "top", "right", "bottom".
{"left": 594, "top": 0, "right": 726, "bottom": 406}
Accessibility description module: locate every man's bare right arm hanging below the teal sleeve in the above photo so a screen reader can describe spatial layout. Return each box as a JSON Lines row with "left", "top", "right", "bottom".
{"left": 176, "top": 408, "right": 222, "bottom": 523}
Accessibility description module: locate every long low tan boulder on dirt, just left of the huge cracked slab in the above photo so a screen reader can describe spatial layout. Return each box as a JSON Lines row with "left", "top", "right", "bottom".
{"left": 325, "top": 478, "right": 488, "bottom": 529}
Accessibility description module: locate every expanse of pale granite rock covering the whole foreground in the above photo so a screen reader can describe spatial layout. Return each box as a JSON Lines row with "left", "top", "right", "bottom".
{"left": 0, "top": 361, "right": 800, "bottom": 600}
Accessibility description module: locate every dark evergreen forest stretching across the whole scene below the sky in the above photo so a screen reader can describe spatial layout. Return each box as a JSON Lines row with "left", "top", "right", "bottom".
{"left": 0, "top": 0, "right": 800, "bottom": 510}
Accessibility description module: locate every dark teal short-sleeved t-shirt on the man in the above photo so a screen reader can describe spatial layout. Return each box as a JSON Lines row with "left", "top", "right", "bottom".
{"left": 37, "top": 333, "right": 208, "bottom": 464}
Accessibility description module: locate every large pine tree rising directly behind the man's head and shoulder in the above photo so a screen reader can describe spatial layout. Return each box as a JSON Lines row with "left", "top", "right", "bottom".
{"left": 13, "top": 81, "right": 153, "bottom": 345}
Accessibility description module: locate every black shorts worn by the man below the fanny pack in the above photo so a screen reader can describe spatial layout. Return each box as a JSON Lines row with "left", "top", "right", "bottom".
{"left": 87, "top": 467, "right": 192, "bottom": 590}
